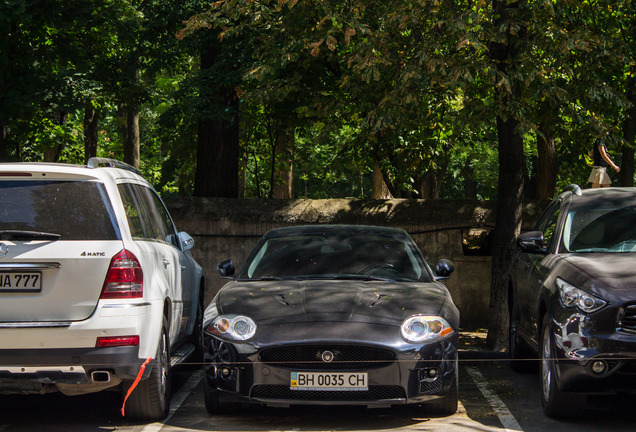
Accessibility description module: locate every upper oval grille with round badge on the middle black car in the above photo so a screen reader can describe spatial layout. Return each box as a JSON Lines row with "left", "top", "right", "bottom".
{"left": 259, "top": 345, "right": 397, "bottom": 370}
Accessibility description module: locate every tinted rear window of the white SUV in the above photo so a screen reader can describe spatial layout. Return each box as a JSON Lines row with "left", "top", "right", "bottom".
{"left": 0, "top": 180, "right": 121, "bottom": 240}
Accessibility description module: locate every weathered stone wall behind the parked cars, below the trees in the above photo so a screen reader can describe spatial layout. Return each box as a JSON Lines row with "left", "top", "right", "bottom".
{"left": 166, "top": 198, "right": 540, "bottom": 330}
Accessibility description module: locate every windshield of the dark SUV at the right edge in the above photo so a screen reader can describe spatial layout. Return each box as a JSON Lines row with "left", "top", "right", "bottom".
{"left": 562, "top": 206, "right": 636, "bottom": 252}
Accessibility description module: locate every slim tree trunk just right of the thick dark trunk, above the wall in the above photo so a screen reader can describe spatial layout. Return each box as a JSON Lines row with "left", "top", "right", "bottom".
{"left": 272, "top": 126, "right": 295, "bottom": 199}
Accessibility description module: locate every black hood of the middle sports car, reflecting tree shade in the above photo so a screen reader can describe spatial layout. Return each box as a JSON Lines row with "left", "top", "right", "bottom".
{"left": 216, "top": 280, "right": 449, "bottom": 325}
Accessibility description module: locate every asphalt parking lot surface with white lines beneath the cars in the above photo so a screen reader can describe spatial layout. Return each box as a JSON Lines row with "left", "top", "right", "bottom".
{"left": 0, "top": 332, "right": 636, "bottom": 432}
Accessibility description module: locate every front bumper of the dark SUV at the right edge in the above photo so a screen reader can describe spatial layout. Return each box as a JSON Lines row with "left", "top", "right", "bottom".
{"left": 551, "top": 310, "right": 636, "bottom": 393}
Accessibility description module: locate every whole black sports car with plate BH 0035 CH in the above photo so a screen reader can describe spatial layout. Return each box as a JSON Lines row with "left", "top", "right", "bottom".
{"left": 204, "top": 225, "right": 459, "bottom": 415}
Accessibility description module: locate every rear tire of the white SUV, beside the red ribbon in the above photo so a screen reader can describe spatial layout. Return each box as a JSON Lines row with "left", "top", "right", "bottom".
{"left": 123, "top": 317, "right": 171, "bottom": 420}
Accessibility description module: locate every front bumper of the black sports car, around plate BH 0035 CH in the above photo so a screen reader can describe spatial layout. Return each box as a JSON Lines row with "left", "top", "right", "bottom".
{"left": 205, "top": 326, "right": 458, "bottom": 407}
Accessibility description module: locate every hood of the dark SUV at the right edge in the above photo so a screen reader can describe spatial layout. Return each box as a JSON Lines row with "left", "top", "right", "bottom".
{"left": 565, "top": 253, "right": 636, "bottom": 290}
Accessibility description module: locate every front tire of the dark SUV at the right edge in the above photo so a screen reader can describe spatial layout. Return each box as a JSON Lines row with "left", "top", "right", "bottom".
{"left": 540, "top": 316, "right": 587, "bottom": 418}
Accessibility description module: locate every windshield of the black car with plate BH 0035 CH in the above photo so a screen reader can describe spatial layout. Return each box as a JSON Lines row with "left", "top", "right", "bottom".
{"left": 239, "top": 234, "right": 431, "bottom": 282}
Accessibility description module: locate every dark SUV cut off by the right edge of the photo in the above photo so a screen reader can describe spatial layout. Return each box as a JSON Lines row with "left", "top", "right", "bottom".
{"left": 510, "top": 186, "right": 636, "bottom": 417}
